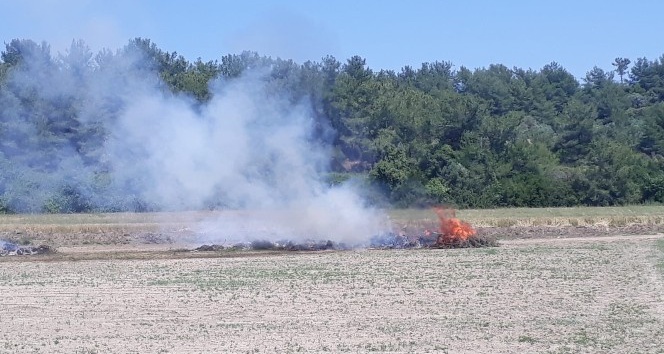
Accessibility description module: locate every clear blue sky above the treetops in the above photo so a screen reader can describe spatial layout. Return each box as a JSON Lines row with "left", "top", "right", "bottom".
{"left": 0, "top": 0, "right": 664, "bottom": 78}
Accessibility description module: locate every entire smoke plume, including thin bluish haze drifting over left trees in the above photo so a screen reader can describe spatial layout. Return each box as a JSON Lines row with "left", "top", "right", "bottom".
{"left": 0, "top": 43, "right": 385, "bottom": 245}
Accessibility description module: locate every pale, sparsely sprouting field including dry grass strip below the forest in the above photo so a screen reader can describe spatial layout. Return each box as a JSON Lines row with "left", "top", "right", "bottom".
{"left": 0, "top": 207, "right": 664, "bottom": 353}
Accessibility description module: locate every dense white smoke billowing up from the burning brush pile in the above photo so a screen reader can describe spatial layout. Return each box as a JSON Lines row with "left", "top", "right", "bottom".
{"left": 108, "top": 75, "right": 383, "bottom": 244}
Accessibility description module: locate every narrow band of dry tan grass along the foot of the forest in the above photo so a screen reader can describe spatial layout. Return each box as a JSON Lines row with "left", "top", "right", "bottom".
{"left": 0, "top": 206, "right": 664, "bottom": 234}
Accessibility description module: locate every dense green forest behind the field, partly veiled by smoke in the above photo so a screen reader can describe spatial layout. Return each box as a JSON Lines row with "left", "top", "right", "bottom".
{"left": 0, "top": 38, "right": 664, "bottom": 213}
